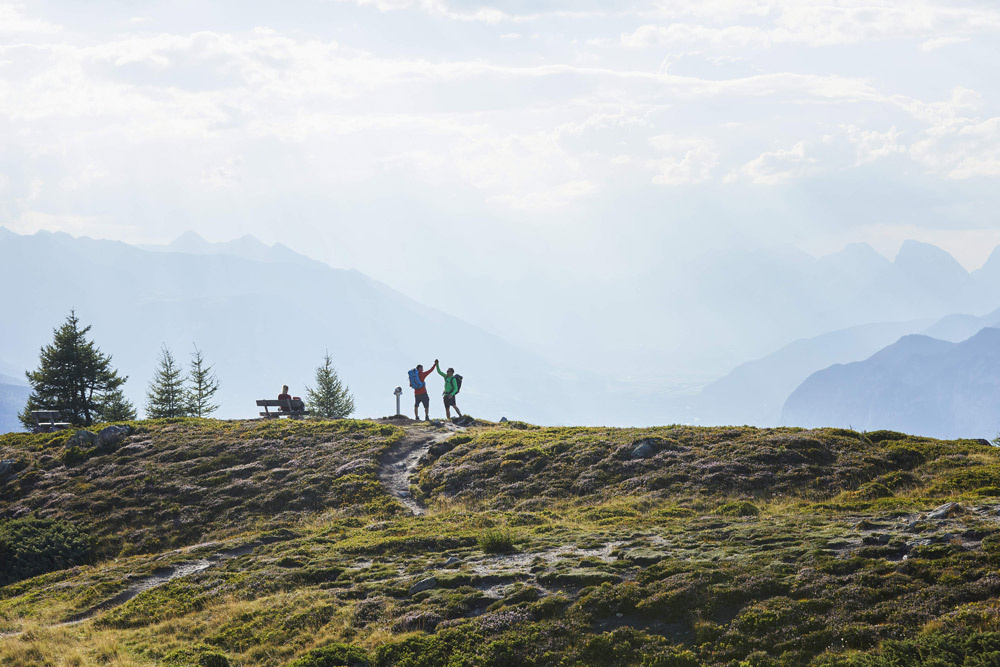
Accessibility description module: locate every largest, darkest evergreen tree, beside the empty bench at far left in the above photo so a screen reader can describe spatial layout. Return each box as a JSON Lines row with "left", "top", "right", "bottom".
{"left": 18, "top": 310, "right": 128, "bottom": 428}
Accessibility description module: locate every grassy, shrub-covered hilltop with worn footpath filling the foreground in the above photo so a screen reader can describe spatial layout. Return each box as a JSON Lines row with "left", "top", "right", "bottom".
{"left": 0, "top": 419, "right": 1000, "bottom": 667}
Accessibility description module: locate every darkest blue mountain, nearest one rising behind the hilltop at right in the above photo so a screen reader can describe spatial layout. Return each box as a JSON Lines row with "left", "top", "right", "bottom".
{"left": 781, "top": 328, "right": 1000, "bottom": 438}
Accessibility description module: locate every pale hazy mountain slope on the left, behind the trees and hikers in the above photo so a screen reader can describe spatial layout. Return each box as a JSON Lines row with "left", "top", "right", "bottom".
{"left": 0, "top": 232, "right": 607, "bottom": 423}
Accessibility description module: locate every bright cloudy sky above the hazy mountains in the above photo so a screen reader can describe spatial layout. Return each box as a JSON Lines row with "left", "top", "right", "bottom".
{"left": 0, "top": 0, "right": 1000, "bottom": 380}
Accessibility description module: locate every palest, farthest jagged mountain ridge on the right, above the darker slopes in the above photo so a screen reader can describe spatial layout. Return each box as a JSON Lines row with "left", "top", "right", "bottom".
{"left": 664, "top": 241, "right": 1000, "bottom": 376}
